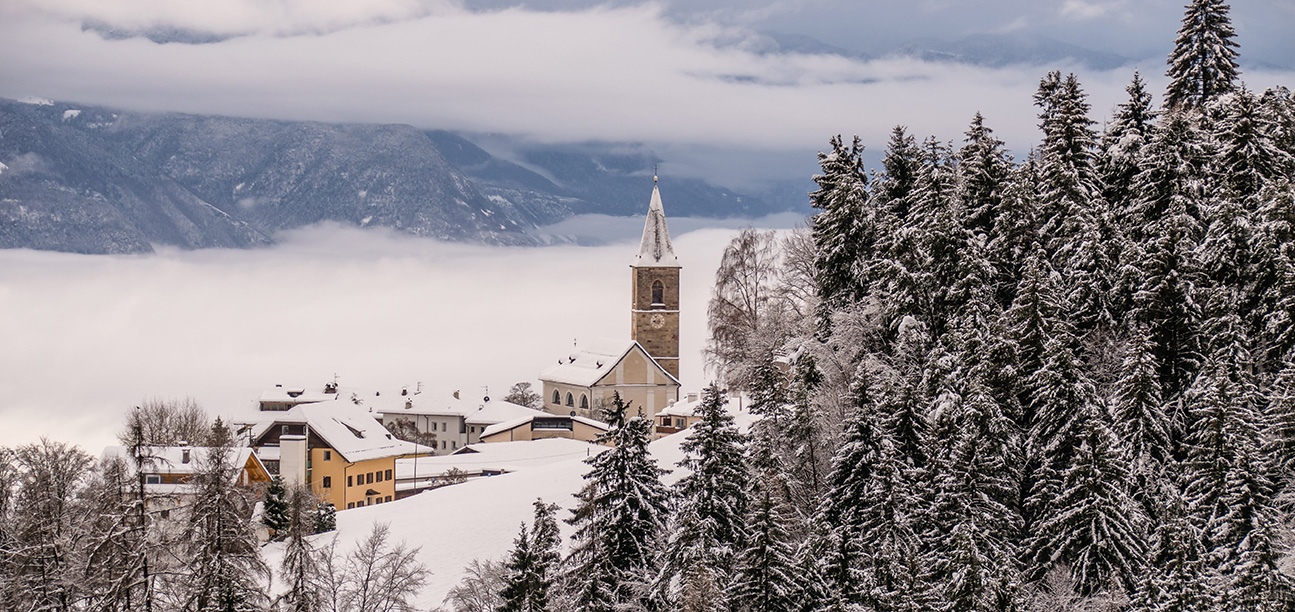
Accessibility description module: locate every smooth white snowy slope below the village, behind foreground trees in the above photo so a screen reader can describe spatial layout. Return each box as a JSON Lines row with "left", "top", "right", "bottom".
{"left": 264, "top": 414, "right": 751, "bottom": 609}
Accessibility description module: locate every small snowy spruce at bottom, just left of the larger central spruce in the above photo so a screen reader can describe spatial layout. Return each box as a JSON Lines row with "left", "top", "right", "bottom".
{"left": 499, "top": 499, "right": 561, "bottom": 612}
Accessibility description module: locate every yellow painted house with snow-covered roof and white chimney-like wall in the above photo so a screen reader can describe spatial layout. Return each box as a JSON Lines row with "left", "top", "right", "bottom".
{"left": 253, "top": 400, "right": 435, "bottom": 510}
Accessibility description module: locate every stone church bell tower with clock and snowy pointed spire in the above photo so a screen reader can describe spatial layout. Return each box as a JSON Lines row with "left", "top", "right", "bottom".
{"left": 629, "top": 176, "right": 682, "bottom": 379}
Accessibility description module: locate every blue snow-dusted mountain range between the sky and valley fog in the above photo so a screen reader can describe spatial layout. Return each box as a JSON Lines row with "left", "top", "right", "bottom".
{"left": 0, "top": 98, "right": 795, "bottom": 254}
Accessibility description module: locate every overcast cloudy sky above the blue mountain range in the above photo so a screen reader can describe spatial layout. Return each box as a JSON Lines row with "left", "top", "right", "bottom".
{"left": 0, "top": 0, "right": 1295, "bottom": 181}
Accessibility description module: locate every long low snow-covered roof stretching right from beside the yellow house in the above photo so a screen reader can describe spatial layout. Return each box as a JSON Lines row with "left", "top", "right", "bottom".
{"left": 395, "top": 437, "right": 607, "bottom": 490}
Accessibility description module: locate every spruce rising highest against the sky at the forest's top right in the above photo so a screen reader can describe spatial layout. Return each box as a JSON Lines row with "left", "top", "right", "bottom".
{"left": 1164, "top": 0, "right": 1241, "bottom": 110}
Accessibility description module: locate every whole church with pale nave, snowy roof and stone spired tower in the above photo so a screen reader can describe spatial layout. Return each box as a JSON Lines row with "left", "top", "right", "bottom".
{"left": 540, "top": 177, "right": 682, "bottom": 418}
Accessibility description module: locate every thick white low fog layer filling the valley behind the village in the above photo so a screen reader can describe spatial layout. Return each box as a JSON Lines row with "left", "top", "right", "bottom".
{"left": 0, "top": 221, "right": 797, "bottom": 453}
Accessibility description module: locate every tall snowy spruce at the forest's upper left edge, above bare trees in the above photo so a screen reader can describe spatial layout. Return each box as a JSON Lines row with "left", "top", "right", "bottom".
{"left": 809, "top": 136, "right": 874, "bottom": 333}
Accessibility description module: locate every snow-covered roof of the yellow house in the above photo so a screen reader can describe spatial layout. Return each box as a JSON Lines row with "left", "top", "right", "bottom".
{"left": 253, "top": 400, "right": 435, "bottom": 463}
